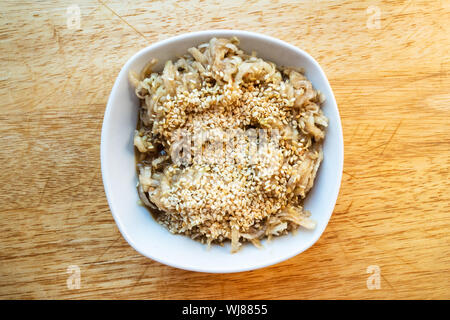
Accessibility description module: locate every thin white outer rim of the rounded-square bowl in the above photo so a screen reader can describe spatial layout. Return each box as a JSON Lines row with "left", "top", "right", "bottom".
{"left": 100, "top": 29, "right": 344, "bottom": 273}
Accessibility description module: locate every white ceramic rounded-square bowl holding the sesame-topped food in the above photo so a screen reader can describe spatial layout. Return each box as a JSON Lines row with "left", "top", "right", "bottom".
{"left": 101, "top": 30, "right": 344, "bottom": 273}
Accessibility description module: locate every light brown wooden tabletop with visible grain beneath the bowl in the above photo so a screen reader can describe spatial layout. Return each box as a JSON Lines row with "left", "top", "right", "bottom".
{"left": 0, "top": 0, "right": 450, "bottom": 299}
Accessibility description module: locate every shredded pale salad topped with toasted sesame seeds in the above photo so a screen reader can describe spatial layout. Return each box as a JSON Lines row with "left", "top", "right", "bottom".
{"left": 130, "top": 38, "right": 328, "bottom": 252}
